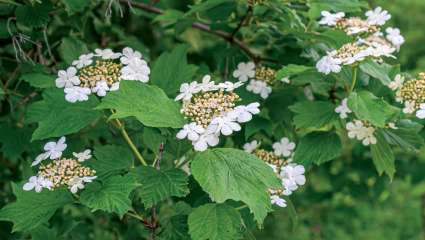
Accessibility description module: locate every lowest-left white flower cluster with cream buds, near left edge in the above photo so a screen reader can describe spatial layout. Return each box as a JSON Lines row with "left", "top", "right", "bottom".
{"left": 23, "top": 137, "right": 96, "bottom": 193}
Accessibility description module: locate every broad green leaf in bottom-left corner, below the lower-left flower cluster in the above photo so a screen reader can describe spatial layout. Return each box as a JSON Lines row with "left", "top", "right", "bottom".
{"left": 0, "top": 183, "right": 73, "bottom": 232}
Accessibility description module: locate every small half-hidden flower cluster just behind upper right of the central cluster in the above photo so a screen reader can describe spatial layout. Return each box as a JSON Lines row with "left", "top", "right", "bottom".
{"left": 233, "top": 62, "right": 276, "bottom": 99}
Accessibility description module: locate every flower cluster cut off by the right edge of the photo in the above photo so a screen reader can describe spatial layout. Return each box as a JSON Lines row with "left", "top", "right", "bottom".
{"left": 388, "top": 73, "right": 425, "bottom": 119}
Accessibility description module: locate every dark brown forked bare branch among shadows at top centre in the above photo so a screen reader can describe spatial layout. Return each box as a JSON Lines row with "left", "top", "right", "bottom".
{"left": 120, "top": 0, "right": 277, "bottom": 63}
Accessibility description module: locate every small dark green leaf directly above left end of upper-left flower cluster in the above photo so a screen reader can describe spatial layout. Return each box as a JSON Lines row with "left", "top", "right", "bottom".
{"left": 59, "top": 37, "right": 89, "bottom": 65}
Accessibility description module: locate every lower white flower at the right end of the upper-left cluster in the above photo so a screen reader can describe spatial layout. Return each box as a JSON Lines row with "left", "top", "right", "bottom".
{"left": 121, "top": 58, "right": 151, "bottom": 83}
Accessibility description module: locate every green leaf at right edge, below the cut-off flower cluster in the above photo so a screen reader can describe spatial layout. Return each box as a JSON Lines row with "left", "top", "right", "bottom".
{"left": 382, "top": 119, "right": 424, "bottom": 150}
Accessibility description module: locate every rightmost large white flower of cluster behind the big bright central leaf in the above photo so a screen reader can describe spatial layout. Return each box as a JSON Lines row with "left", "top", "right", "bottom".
{"left": 280, "top": 164, "right": 306, "bottom": 195}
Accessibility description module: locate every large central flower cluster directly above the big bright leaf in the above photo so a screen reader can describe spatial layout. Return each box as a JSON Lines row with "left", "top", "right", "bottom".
{"left": 175, "top": 75, "right": 260, "bottom": 151}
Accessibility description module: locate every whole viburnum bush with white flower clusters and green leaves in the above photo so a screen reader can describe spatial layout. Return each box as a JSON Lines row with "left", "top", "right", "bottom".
{"left": 0, "top": 0, "right": 425, "bottom": 240}
